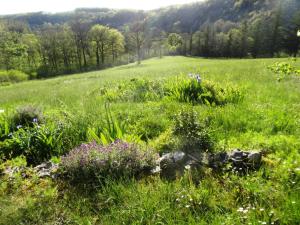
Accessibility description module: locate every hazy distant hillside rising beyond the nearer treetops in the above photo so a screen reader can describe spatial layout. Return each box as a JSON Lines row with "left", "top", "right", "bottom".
{"left": 2, "top": 0, "right": 280, "bottom": 32}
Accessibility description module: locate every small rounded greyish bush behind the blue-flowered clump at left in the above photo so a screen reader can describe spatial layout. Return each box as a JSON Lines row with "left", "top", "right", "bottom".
{"left": 12, "top": 105, "right": 44, "bottom": 127}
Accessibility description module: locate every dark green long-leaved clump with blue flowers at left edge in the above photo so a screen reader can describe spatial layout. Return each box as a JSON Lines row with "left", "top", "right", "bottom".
{"left": 0, "top": 124, "right": 63, "bottom": 165}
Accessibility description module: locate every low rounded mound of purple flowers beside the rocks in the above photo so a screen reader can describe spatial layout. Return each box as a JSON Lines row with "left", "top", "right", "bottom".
{"left": 61, "top": 140, "right": 157, "bottom": 183}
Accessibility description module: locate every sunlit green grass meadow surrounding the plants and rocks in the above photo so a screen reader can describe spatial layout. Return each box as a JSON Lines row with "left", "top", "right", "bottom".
{"left": 0, "top": 57, "right": 300, "bottom": 225}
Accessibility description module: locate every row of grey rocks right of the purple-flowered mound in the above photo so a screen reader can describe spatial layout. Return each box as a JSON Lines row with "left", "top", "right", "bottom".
{"left": 156, "top": 149, "right": 262, "bottom": 180}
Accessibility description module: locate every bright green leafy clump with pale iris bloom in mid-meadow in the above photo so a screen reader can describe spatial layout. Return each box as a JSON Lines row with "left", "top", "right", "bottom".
{"left": 166, "top": 75, "right": 243, "bottom": 105}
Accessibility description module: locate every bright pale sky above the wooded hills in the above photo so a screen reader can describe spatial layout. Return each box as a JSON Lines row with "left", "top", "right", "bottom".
{"left": 0, "top": 0, "right": 201, "bottom": 15}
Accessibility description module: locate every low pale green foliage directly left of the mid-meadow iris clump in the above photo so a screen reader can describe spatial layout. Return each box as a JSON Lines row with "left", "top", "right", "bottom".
{"left": 100, "top": 79, "right": 164, "bottom": 102}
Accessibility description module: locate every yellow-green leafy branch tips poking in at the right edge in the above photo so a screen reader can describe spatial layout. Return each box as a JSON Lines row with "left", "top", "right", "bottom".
{"left": 268, "top": 62, "right": 300, "bottom": 82}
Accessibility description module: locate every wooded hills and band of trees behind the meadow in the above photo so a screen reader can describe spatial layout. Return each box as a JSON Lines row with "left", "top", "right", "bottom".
{"left": 0, "top": 0, "right": 300, "bottom": 78}
